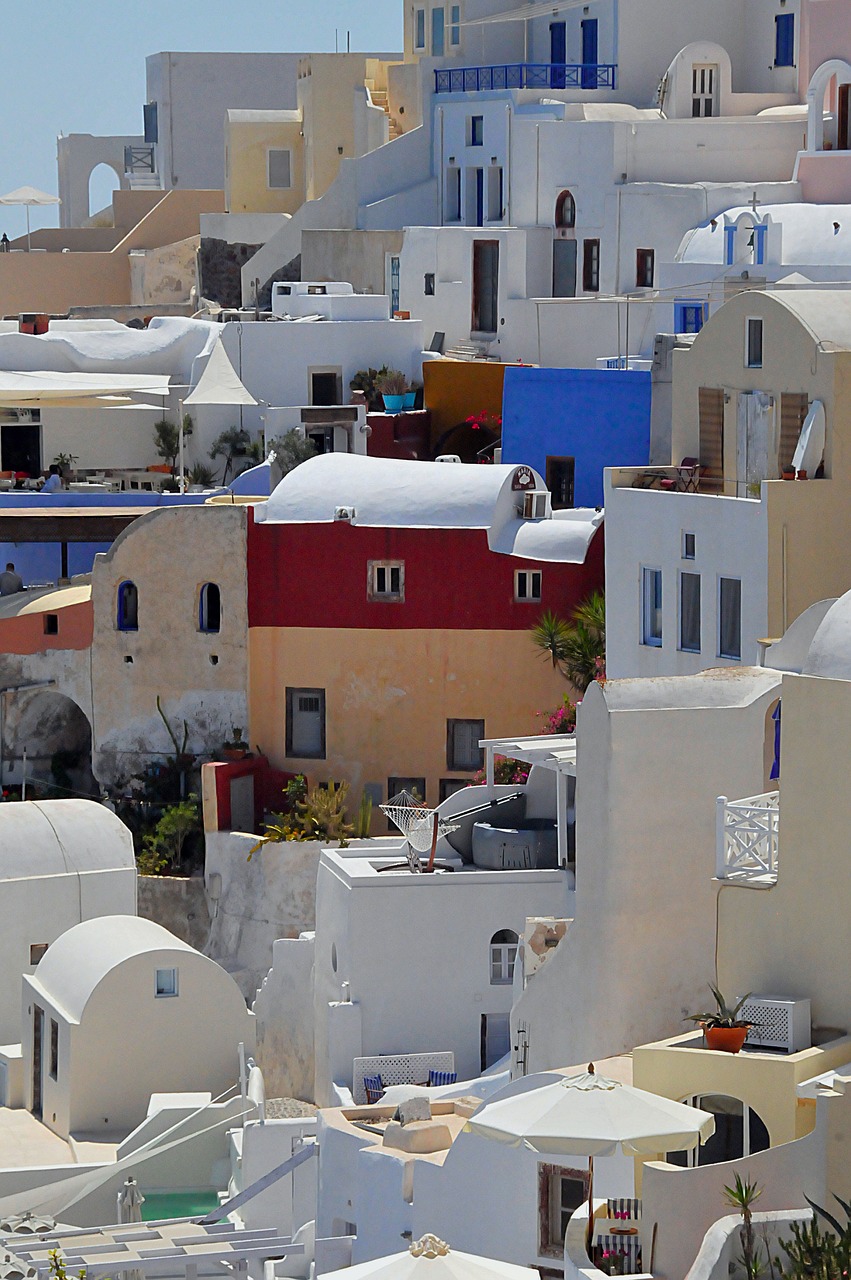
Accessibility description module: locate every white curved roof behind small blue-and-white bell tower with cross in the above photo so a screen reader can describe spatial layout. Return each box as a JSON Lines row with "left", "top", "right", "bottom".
{"left": 677, "top": 202, "right": 851, "bottom": 266}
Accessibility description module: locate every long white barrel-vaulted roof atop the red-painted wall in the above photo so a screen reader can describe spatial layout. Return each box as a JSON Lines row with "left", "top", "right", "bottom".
{"left": 255, "top": 453, "right": 546, "bottom": 529}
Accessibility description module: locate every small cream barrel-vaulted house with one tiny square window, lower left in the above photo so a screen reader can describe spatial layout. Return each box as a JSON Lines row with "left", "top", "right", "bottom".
{"left": 23, "top": 915, "right": 255, "bottom": 1138}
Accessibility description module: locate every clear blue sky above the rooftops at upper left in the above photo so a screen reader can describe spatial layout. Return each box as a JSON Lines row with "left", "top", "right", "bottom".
{"left": 0, "top": 0, "right": 402, "bottom": 237}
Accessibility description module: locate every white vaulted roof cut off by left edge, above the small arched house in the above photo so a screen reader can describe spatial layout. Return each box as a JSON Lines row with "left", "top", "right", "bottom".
{"left": 0, "top": 800, "right": 136, "bottom": 881}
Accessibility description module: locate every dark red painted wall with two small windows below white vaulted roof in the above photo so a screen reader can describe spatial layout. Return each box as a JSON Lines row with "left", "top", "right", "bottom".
{"left": 248, "top": 509, "right": 604, "bottom": 631}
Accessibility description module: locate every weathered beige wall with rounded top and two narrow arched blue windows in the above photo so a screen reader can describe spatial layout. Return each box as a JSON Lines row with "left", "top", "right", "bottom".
{"left": 92, "top": 506, "right": 248, "bottom": 782}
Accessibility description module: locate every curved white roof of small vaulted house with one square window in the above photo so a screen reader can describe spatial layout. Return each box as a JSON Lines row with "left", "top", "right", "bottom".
{"left": 31, "top": 915, "right": 195, "bottom": 1021}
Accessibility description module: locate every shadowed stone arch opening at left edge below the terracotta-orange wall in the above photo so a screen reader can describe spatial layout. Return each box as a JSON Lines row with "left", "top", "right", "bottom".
{"left": 0, "top": 685, "right": 100, "bottom": 800}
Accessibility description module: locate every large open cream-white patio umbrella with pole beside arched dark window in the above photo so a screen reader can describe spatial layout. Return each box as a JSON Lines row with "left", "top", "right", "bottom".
{"left": 465, "top": 1062, "right": 715, "bottom": 1247}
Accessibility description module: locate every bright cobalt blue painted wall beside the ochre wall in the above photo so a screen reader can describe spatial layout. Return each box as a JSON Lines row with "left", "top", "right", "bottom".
{"left": 503, "top": 365, "right": 651, "bottom": 507}
